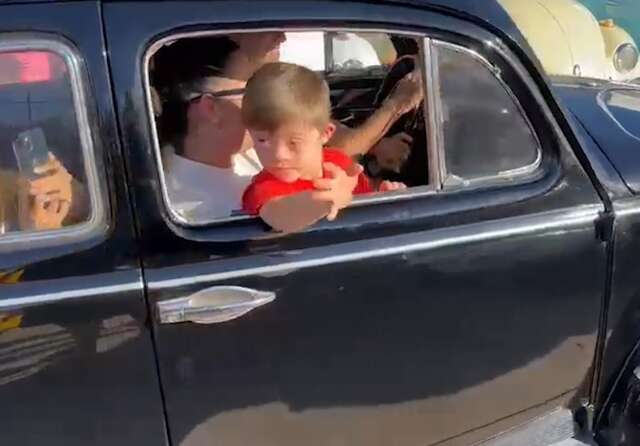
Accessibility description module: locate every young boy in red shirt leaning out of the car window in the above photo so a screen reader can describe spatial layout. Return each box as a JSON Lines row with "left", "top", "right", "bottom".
{"left": 242, "top": 63, "right": 406, "bottom": 231}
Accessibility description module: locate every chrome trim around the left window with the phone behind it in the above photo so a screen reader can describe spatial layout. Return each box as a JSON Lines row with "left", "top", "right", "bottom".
{"left": 0, "top": 33, "right": 108, "bottom": 252}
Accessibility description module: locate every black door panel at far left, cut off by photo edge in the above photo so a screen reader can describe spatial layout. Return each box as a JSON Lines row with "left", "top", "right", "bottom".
{"left": 0, "top": 2, "right": 166, "bottom": 446}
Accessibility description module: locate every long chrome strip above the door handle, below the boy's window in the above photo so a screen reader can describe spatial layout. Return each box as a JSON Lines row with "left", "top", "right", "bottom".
{"left": 147, "top": 205, "right": 604, "bottom": 291}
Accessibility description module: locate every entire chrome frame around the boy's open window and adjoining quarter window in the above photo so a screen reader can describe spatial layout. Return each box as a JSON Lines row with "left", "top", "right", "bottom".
{"left": 141, "top": 24, "right": 545, "bottom": 230}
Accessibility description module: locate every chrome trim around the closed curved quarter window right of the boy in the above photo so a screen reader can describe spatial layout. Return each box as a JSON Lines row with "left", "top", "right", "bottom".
{"left": 432, "top": 39, "right": 542, "bottom": 189}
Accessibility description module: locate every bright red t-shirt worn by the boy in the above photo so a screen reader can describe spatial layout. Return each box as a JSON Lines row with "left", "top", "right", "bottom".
{"left": 242, "top": 149, "right": 373, "bottom": 215}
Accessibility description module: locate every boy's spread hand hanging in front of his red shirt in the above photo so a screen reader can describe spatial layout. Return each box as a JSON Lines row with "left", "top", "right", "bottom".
{"left": 311, "top": 163, "right": 362, "bottom": 221}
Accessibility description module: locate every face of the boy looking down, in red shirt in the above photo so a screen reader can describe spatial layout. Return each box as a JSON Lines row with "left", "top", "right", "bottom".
{"left": 249, "top": 122, "right": 335, "bottom": 183}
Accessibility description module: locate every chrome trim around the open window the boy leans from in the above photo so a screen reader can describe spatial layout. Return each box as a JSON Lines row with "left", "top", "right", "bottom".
{"left": 142, "top": 26, "right": 436, "bottom": 228}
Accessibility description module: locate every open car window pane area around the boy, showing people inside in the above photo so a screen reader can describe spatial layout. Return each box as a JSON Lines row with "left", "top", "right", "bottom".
{"left": 148, "top": 30, "right": 429, "bottom": 226}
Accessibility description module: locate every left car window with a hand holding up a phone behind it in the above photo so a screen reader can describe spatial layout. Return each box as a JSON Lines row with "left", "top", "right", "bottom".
{"left": 0, "top": 41, "right": 101, "bottom": 241}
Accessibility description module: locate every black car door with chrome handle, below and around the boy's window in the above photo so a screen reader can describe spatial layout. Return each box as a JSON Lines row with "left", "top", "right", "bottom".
{"left": 104, "top": 1, "right": 605, "bottom": 445}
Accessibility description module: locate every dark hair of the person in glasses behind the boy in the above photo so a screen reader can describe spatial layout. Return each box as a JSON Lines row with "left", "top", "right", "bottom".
{"left": 151, "top": 36, "right": 238, "bottom": 153}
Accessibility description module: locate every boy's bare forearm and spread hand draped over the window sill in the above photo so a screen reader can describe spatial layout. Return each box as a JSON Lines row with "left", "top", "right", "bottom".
{"left": 260, "top": 163, "right": 362, "bottom": 233}
